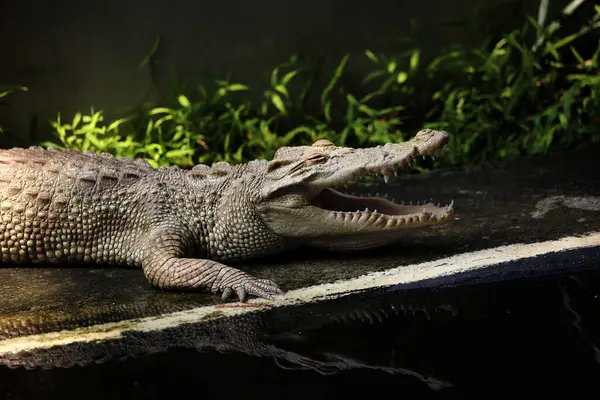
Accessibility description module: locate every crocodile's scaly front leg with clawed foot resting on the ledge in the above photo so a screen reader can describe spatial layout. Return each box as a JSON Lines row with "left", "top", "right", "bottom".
{"left": 142, "top": 230, "right": 283, "bottom": 302}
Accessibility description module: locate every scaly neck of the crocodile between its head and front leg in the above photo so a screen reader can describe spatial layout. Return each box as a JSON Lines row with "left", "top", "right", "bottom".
{"left": 158, "top": 160, "right": 298, "bottom": 261}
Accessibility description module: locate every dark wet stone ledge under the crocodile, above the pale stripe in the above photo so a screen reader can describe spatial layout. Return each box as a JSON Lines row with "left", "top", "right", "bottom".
{"left": 0, "top": 144, "right": 600, "bottom": 340}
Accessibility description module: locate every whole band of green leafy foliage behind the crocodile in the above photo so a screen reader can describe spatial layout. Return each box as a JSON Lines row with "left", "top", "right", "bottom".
{"left": 44, "top": 3, "right": 600, "bottom": 168}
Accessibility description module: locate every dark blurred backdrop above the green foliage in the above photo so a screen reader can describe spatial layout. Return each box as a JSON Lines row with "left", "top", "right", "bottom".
{"left": 0, "top": 0, "right": 556, "bottom": 143}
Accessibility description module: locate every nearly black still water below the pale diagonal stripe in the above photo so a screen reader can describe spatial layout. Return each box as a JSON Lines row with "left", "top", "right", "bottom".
{"left": 0, "top": 262, "right": 600, "bottom": 399}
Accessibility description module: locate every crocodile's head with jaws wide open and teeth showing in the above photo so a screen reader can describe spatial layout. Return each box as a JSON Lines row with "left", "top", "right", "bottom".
{"left": 257, "top": 129, "right": 454, "bottom": 250}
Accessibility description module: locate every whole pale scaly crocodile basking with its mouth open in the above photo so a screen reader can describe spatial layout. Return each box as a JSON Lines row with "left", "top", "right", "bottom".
{"left": 0, "top": 129, "right": 454, "bottom": 302}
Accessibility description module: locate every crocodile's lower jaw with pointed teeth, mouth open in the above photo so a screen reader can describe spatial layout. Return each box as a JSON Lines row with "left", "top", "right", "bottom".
{"left": 260, "top": 189, "right": 454, "bottom": 247}
